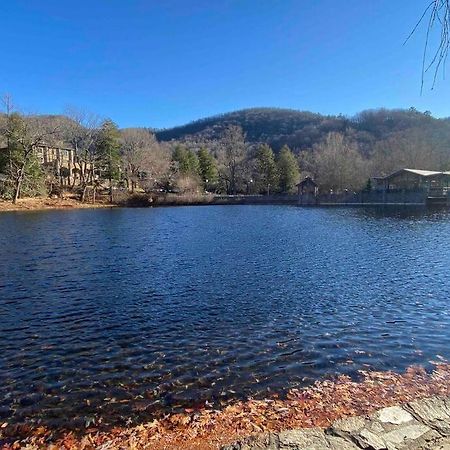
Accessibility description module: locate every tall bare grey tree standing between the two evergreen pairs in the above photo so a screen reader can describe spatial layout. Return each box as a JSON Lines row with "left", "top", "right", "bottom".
{"left": 217, "top": 125, "right": 246, "bottom": 195}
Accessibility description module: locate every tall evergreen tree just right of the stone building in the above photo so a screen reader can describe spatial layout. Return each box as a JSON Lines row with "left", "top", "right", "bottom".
{"left": 97, "top": 119, "right": 121, "bottom": 203}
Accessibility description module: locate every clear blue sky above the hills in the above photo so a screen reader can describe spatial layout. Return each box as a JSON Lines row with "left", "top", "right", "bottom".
{"left": 0, "top": 0, "right": 450, "bottom": 127}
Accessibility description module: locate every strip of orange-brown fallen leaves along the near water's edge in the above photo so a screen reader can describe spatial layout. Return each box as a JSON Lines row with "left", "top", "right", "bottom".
{"left": 0, "top": 363, "right": 450, "bottom": 450}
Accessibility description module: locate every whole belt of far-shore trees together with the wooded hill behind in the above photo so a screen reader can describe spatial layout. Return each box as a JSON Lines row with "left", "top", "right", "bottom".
{"left": 0, "top": 107, "right": 450, "bottom": 201}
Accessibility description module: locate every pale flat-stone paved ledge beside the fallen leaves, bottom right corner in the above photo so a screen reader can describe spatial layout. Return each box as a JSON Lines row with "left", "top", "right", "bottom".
{"left": 223, "top": 397, "right": 450, "bottom": 450}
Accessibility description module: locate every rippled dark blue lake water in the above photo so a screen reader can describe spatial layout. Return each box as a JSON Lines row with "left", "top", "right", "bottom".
{"left": 0, "top": 206, "right": 450, "bottom": 425}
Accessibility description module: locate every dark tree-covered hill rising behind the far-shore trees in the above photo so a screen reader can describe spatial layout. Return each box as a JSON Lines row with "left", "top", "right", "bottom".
{"left": 156, "top": 108, "right": 450, "bottom": 152}
